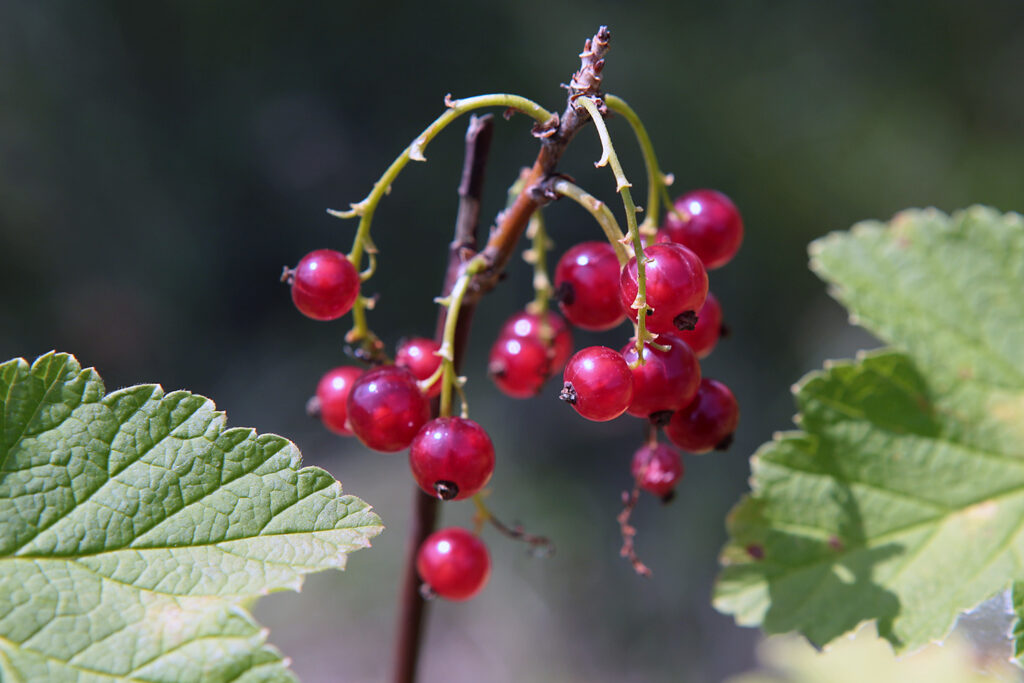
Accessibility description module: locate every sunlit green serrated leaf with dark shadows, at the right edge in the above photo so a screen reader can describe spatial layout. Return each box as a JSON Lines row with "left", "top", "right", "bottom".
{"left": 715, "top": 207, "right": 1024, "bottom": 650}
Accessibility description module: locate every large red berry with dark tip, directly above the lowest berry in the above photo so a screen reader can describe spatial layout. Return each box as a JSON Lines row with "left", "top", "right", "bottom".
{"left": 409, "top": 418, "right": 495, "bottom": 501}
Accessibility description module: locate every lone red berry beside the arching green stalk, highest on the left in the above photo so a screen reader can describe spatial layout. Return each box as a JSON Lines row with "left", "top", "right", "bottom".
{"left": 291, "top": 249, "right": 359, "bottom": 321}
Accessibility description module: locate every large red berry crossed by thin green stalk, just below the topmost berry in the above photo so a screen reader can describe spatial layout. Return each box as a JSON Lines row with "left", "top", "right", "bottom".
{"left": 620, "top": 242, "right": 708, "bottom": 334}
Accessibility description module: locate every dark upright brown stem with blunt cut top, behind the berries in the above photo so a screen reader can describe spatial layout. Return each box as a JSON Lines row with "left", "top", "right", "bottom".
{"left": 393, "top": 115, "right": 494, "bottom": 683}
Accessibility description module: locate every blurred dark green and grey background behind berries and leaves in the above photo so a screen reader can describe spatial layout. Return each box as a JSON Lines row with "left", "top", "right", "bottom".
{"left": 0, "top": 0, "right": 1024, "bottom": 682}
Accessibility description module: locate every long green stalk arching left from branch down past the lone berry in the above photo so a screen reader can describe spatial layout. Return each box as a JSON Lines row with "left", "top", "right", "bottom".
{"left": 328, "top": 93, "right": 553, "bottom": 342}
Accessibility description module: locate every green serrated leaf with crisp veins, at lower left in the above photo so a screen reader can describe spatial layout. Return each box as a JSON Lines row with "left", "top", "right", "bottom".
{"left": 0, "top": 353, "right": 382, "bottom": 683}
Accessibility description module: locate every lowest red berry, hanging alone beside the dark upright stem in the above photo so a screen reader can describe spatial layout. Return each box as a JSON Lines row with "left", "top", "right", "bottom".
{"left": 416, "top": 526, "right": 490, "bottom": 600}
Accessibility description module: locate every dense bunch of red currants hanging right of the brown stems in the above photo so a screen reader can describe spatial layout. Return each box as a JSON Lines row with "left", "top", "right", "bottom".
{"left": 489, "top": 189, "right": 743, "bottom": 498}
